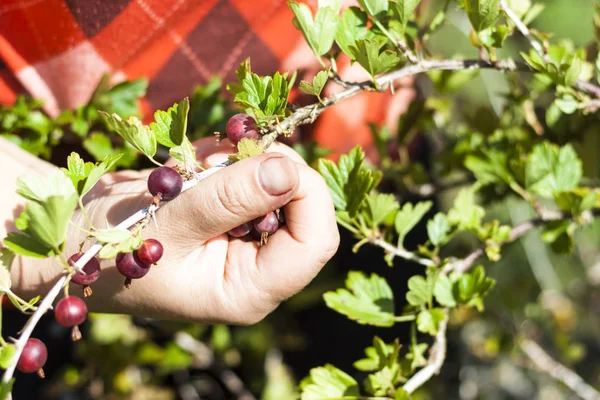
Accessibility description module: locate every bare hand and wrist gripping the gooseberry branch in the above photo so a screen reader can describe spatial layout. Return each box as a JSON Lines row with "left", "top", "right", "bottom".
{"left": 11, "top": 138, "right": 339, "bottom": 325}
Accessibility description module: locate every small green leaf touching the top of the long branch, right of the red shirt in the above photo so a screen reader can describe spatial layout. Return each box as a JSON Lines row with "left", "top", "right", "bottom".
{"left": 349, "top": 39, "right": 400, "bottom": 79}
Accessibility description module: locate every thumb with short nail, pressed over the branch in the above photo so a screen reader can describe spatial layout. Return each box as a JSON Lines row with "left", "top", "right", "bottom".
{"left": 169, "top": 153, "right": 299, "bottom": 240}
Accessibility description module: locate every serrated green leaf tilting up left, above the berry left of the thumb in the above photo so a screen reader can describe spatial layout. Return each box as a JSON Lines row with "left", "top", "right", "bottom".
{"left": 98, "top": 111, "right": 156, "bottom": 159}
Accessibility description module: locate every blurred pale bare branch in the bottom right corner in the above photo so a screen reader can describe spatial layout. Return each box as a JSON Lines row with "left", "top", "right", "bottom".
{"left": 520, "top": 339, "right": 600, "bottom": 400}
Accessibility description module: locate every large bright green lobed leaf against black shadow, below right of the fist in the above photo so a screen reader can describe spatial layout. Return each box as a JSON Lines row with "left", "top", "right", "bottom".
{"left": 323, "top": 271, "right": 394, "bottom": 327}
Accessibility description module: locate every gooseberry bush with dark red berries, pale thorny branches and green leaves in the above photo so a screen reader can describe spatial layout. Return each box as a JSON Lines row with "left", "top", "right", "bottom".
{"left": 0, "top": 0, "right": 600, "bottom": 400}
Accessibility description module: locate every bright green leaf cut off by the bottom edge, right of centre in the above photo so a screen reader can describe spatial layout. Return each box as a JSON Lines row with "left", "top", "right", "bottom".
{"left": 300, "top": 364, "right": 360, "bottom": 400}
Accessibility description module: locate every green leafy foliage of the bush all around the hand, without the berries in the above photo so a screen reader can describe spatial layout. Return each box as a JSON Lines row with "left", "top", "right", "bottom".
{"left": 0, "top": 0, "right": 600, "bottom": 400}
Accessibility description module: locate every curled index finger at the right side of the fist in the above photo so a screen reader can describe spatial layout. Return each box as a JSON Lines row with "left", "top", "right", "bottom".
{"left": 248, "top": 166, "right": 340, "bottom": 301}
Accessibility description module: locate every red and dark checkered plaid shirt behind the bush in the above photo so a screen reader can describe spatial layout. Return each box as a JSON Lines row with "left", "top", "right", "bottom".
{"left": 0, "top": 0, "right": 412, "bottom": 158}
